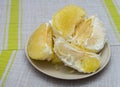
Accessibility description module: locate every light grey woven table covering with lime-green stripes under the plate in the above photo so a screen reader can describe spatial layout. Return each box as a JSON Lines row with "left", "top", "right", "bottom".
{"left": 0, "top": 0, "right": 120, "bottom": 87}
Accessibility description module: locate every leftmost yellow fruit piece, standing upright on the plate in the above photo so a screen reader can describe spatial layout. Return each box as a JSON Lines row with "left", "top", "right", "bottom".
{"left": 27, "top": 23, "right": 53, "bottom": 60}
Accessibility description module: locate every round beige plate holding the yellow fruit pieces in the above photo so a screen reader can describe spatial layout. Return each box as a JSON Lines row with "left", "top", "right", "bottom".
{"left": 25, "top": 42, "right": 110, "bottom": 80}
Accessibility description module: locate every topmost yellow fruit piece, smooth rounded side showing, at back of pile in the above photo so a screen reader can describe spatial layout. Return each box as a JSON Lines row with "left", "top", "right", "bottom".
{"left": 52, "top": 5, "right": 86, "bottom": 37}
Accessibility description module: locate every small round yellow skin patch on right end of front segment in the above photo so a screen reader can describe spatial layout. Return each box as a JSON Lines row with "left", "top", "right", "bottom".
{"left": 81, "top": 57, "right": 100, "bottom": 73}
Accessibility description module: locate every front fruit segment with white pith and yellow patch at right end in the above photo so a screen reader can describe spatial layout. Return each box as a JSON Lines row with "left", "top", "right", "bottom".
{"left": 54, "top": 38, "right": 100, "bottom": 73}
